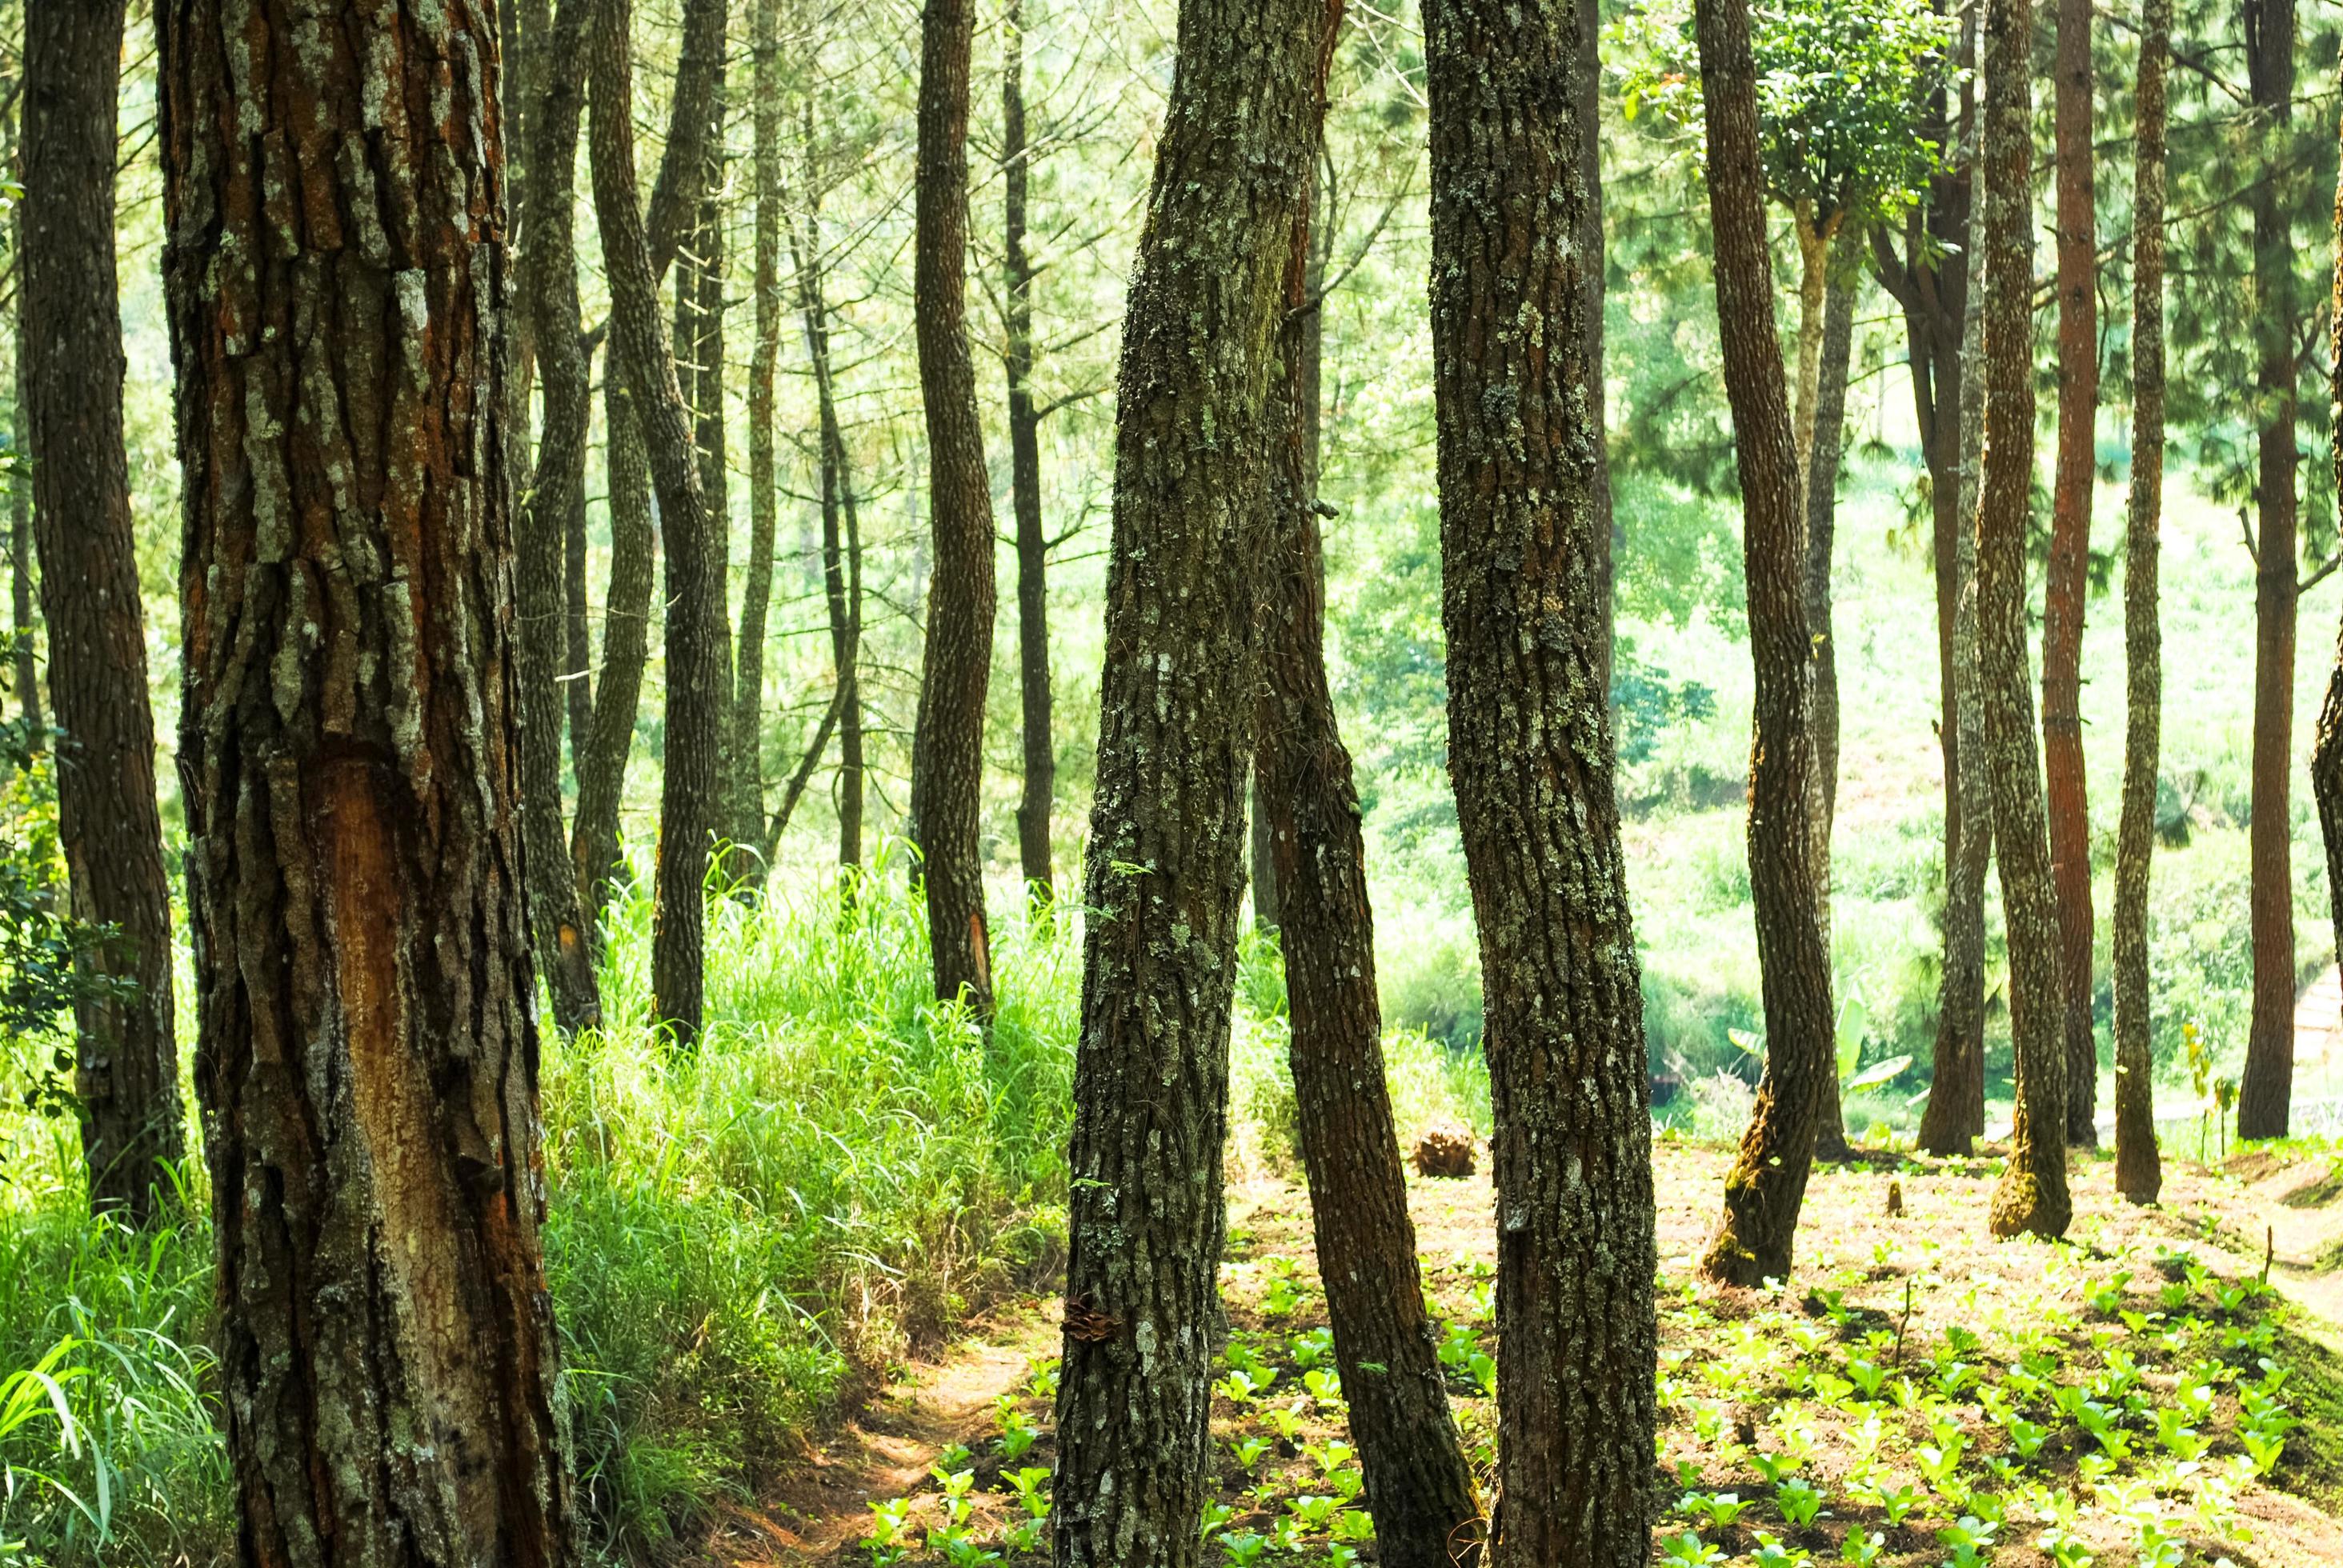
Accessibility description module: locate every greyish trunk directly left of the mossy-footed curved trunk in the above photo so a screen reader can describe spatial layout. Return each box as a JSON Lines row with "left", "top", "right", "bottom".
{"left": 1919, "top": 207, "right": 1994, "bottom": 1155}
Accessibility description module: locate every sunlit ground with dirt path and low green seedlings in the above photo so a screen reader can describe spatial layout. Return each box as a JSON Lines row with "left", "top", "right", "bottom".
{"left": 689, "top": 1142, "right": 2343, "bottom": 1568}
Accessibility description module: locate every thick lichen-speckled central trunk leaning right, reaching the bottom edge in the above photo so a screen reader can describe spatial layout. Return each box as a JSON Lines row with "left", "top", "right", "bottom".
{"left": 1052, "top": 0, "right": 1331, "bottom": 1568}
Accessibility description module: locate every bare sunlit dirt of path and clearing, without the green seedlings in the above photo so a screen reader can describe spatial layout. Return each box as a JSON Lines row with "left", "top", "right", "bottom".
{"left": 691, "top": 1142, "right": 2343, "bottom": 1568}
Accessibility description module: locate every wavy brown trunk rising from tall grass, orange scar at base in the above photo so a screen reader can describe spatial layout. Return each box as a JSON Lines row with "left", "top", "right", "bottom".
{"left": 911, "top": 0, "right": 993, "bottom": 1018}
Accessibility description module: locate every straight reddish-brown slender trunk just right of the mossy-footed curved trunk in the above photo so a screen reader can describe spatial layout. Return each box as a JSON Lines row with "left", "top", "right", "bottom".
{"left": 2043, "top": 0, "right": 2099, "bottom": 1146}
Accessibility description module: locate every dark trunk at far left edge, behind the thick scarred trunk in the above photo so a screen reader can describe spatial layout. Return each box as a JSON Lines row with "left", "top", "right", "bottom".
{"left": 18, "top": 0, "right": 182, "bottom": 1223}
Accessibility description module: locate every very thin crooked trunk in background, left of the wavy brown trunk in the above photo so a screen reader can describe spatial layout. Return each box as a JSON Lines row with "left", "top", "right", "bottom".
{"left": 790, "top": 154, "right": 863, "bottom": 867}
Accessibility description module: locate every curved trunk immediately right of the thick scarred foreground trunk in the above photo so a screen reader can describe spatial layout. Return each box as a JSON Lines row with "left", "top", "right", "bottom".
{"left": 513, "top": 0, "right": 602, "bottom": 1034}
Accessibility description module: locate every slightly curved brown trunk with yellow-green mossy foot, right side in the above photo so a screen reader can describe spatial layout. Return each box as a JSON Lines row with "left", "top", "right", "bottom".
{"left": 1977, "top": 0, "right": 2073, "bottom": 1238}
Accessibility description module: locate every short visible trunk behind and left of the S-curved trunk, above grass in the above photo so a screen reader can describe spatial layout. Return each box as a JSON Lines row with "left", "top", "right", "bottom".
{"left": 570, "top": 363, "right": 659, "bottom": 930}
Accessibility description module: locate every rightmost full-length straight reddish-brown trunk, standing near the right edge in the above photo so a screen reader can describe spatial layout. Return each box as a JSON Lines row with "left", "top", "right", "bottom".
{"left": 2237, "top": 0, "right": 2301, "bottom": 1139}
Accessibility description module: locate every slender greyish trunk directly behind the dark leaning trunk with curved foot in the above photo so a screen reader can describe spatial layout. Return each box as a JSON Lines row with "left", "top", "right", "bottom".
{"left": 1804, "top": 235, "right": 1863, "bottom": 1160}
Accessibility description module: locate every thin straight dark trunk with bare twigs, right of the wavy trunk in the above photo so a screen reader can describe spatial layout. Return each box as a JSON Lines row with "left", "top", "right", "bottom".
{"left": 1000, "top": 0, "right": 1057, "bottom": 902}
